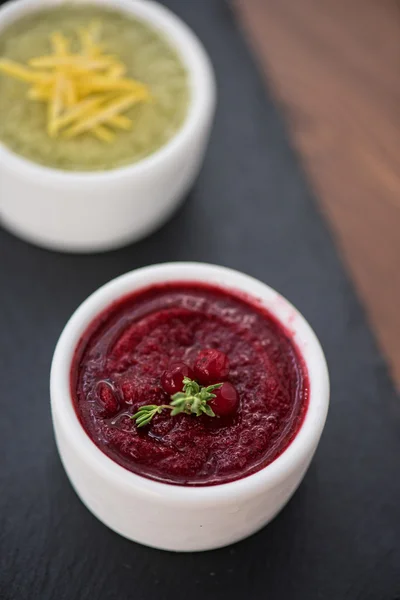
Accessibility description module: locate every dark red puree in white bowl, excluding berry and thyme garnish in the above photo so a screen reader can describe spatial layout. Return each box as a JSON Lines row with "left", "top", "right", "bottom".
{"left": 71, "top": 283, "right": 309, "bottom": 486}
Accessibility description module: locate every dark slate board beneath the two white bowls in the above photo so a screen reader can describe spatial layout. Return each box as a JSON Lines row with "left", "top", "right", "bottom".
{"left": 0, "top": 0, "right": 400, "bottom": 600}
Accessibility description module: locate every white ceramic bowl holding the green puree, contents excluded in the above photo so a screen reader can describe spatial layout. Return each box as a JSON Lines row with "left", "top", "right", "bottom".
{"left": 0, "top": 0, "right": 216, "bottom": 252}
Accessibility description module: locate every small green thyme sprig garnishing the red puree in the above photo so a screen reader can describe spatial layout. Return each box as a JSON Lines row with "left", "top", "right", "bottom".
{"left": 131, "top": 377, "right": 222, "bottom": 427}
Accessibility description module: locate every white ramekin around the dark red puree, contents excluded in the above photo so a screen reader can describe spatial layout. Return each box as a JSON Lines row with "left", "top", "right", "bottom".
{"left": 50, "top": 263, "right": 329, "bottom": 551}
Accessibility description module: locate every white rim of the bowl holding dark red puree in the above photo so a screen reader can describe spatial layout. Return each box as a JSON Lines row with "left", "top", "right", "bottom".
{"left": 50, "top": 262, "right": 329, "bottom": 505}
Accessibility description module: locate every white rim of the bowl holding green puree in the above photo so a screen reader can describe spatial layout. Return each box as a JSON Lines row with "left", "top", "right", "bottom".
{"left": 0, "top": 0, "right": 216, "bottom": 180}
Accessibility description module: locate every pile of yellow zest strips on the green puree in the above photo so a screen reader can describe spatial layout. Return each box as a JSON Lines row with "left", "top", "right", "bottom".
{"left": 0, "top": 21, "right": 151, "bottom": 142}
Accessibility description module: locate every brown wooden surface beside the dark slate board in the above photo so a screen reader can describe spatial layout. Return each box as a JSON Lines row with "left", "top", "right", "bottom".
{"left": 236, "top": 0, "right": 400, "bottom": 385}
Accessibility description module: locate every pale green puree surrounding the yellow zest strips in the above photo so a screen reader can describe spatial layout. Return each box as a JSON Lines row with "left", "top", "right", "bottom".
{"left": 0, "top": 4, "right": 189, "bottom": 171}
